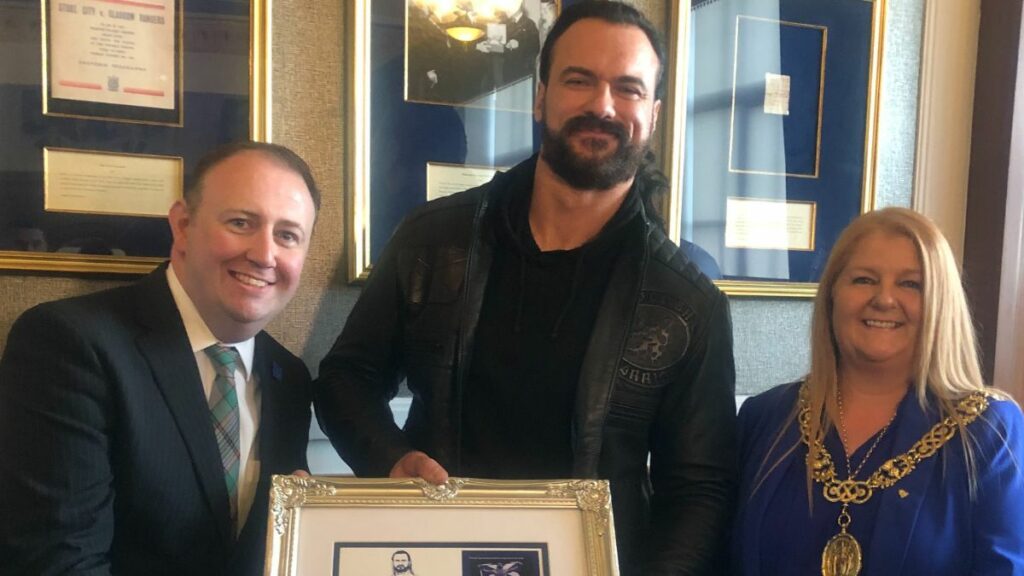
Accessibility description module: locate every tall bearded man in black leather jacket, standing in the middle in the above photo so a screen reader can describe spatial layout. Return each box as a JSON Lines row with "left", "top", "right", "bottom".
{"left": 315, "top": 2, "right": 735, "bottom": 575}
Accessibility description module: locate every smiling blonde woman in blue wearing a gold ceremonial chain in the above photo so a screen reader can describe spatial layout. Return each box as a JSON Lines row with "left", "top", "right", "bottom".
{"left": 733, "top": 208, "right": 1024, "bottom": 576}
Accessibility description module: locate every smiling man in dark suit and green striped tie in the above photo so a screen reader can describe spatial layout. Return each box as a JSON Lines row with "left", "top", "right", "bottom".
{"left": 0, "top": 142, "right": 319, "bottom": 575}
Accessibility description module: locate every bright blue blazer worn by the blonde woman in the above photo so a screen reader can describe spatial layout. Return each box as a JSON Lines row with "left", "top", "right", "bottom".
{"left": 733, "top": 382, "right": 1024, "bottom": 576}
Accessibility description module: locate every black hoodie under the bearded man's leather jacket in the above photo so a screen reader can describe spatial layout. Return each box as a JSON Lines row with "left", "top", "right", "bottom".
{"left": 462, "top": 161, "right": 643, "bottom": 479}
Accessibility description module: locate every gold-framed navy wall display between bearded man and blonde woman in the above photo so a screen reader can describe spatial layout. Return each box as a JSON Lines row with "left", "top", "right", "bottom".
{"left": 671, "top": 0, "right": 885, "bottom": 296}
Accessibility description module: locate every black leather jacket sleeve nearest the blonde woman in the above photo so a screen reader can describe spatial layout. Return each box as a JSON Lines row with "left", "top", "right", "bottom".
{"left": 643, "top": 294, "right": 737, "bottom": 575}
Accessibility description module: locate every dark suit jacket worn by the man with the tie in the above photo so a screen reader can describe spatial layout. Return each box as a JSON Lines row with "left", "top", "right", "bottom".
{"left": 0, "top": 266, "right": 310, "bottom": 575}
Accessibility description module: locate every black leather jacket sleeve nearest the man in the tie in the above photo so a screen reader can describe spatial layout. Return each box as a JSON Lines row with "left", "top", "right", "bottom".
{"left": 313, "top": 229, "right": 412, "bottom": 477}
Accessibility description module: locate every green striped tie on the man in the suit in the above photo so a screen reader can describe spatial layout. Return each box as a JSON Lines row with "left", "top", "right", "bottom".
{"left": 203, "top": 344, "right": 241, "bottom": 524}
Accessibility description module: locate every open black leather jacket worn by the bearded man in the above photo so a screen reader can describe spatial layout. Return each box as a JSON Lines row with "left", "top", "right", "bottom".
{"left": 315, "top": 154, "right": 736, "bottom": 574}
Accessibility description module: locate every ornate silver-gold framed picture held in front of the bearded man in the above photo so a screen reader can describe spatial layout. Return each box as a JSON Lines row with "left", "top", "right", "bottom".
{"left": 266, "top": 476, "right": 618, "bottom": 576}
